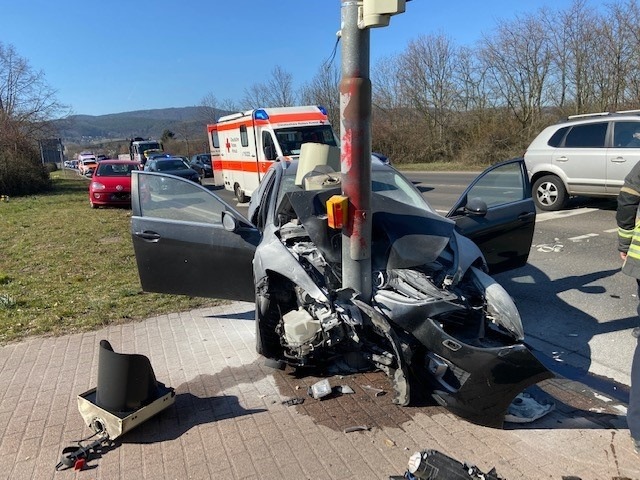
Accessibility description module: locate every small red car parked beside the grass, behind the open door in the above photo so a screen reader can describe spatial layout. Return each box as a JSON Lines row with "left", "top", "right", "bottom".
{"left": 89, "top": 160, "right": 139, "bottom": 208}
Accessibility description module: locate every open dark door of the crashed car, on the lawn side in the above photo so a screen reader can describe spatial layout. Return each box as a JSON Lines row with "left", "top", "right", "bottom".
{"left": 131, "top": 171, "right": 260, "bottom": 302}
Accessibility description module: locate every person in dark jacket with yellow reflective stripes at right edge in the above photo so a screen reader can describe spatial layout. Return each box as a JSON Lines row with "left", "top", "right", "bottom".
{"left": 616, "top": 162, "right": 640, "bottom": 453}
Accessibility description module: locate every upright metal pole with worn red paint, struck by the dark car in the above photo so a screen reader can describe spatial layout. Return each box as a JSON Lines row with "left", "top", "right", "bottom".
{"left": 340, "top": 0, "right": 371, "bottom": 301}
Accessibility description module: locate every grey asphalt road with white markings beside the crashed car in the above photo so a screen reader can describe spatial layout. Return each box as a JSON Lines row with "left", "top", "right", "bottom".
{"left": 204, "top": 172, "right": 640, "bottom": 400}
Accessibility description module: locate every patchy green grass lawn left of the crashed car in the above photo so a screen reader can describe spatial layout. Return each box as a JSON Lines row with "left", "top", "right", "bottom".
{"left": 0, "top": 170, "right": 219, "bottom": 343}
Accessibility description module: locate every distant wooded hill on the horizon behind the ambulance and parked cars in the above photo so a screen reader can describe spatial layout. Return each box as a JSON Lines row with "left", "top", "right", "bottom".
{"left": 53, "top": 107, "right": 228, "bottom": 145}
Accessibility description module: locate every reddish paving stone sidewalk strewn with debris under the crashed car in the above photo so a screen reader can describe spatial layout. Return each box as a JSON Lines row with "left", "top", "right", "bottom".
{"left": 0, "top": 302, "right": 640, "bottom": 480}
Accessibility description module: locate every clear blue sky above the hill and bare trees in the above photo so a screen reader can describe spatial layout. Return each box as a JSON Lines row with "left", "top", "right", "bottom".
{"left": 0, "top": 0, "right": 595, "bottom": 115}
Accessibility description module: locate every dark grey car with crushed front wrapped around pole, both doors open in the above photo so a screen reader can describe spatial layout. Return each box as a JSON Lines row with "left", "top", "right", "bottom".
{"left": 131, "top": 159, "right": 552, "bottom": 427}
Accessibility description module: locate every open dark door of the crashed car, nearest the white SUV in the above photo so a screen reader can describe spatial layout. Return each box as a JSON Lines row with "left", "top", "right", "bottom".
{"left": 447, "top": 158, "right": 536, "bottom": 274}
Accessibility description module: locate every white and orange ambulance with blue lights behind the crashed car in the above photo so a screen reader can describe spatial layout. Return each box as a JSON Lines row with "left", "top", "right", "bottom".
{"left": 207, "top": 106, "right": 338, "bottom": 203}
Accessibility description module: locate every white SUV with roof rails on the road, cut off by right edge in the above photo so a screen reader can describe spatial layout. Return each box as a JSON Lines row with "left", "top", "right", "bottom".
{"left": 524, "top": 110, "right": 640, "bottom": 210}
